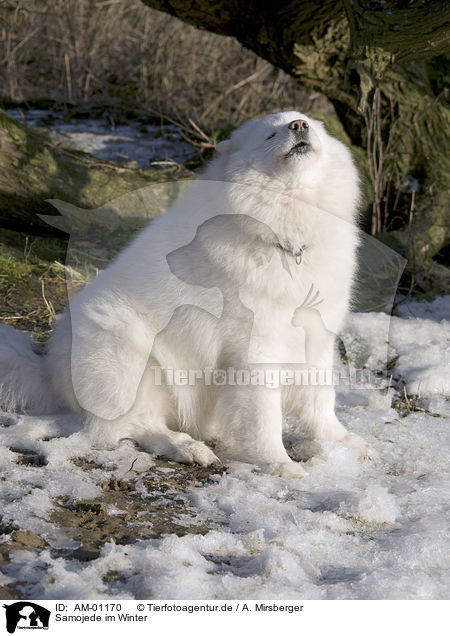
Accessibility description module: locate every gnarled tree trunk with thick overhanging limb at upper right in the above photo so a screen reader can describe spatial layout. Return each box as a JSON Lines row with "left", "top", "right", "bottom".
{"left": 143, "top": 0, "right": 450, "bottom": 289}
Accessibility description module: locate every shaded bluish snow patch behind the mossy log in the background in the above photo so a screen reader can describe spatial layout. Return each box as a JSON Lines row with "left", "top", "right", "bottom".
{"left": 7, "top": 108, "right": 195, "bottom": 168}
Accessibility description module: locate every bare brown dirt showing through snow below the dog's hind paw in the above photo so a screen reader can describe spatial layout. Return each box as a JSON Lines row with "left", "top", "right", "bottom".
{"left": 0, "top": 453, "right": 224, "bottom": 600}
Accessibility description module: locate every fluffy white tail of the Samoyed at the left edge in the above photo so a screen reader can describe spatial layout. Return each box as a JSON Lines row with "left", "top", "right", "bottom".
{"left": 0, "top": 325, "right": 58, "bottom": 414}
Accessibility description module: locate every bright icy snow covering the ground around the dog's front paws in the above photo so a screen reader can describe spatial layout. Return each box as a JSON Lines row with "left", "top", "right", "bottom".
{"left": 0, "top": 297, "right": 450, "bottom": 600}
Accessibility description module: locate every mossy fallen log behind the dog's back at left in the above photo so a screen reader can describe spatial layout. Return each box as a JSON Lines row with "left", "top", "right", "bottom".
{"left": 0, "top": 110, "right": 190, "bottom": 235}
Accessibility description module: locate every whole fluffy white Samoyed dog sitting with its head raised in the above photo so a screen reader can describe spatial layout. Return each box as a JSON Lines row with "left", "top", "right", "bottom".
{"left": 0, "top": 112, "right": 367, "bottom": 477}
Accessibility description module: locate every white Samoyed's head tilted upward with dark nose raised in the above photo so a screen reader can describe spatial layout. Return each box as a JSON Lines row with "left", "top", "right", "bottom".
{"left": 210, "top": 111, "right": 359, "bottom": 218}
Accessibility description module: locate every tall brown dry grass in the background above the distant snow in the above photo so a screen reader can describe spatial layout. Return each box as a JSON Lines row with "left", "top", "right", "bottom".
{"left": 0, "top": 0, "right": 326, "bottom": 132}
